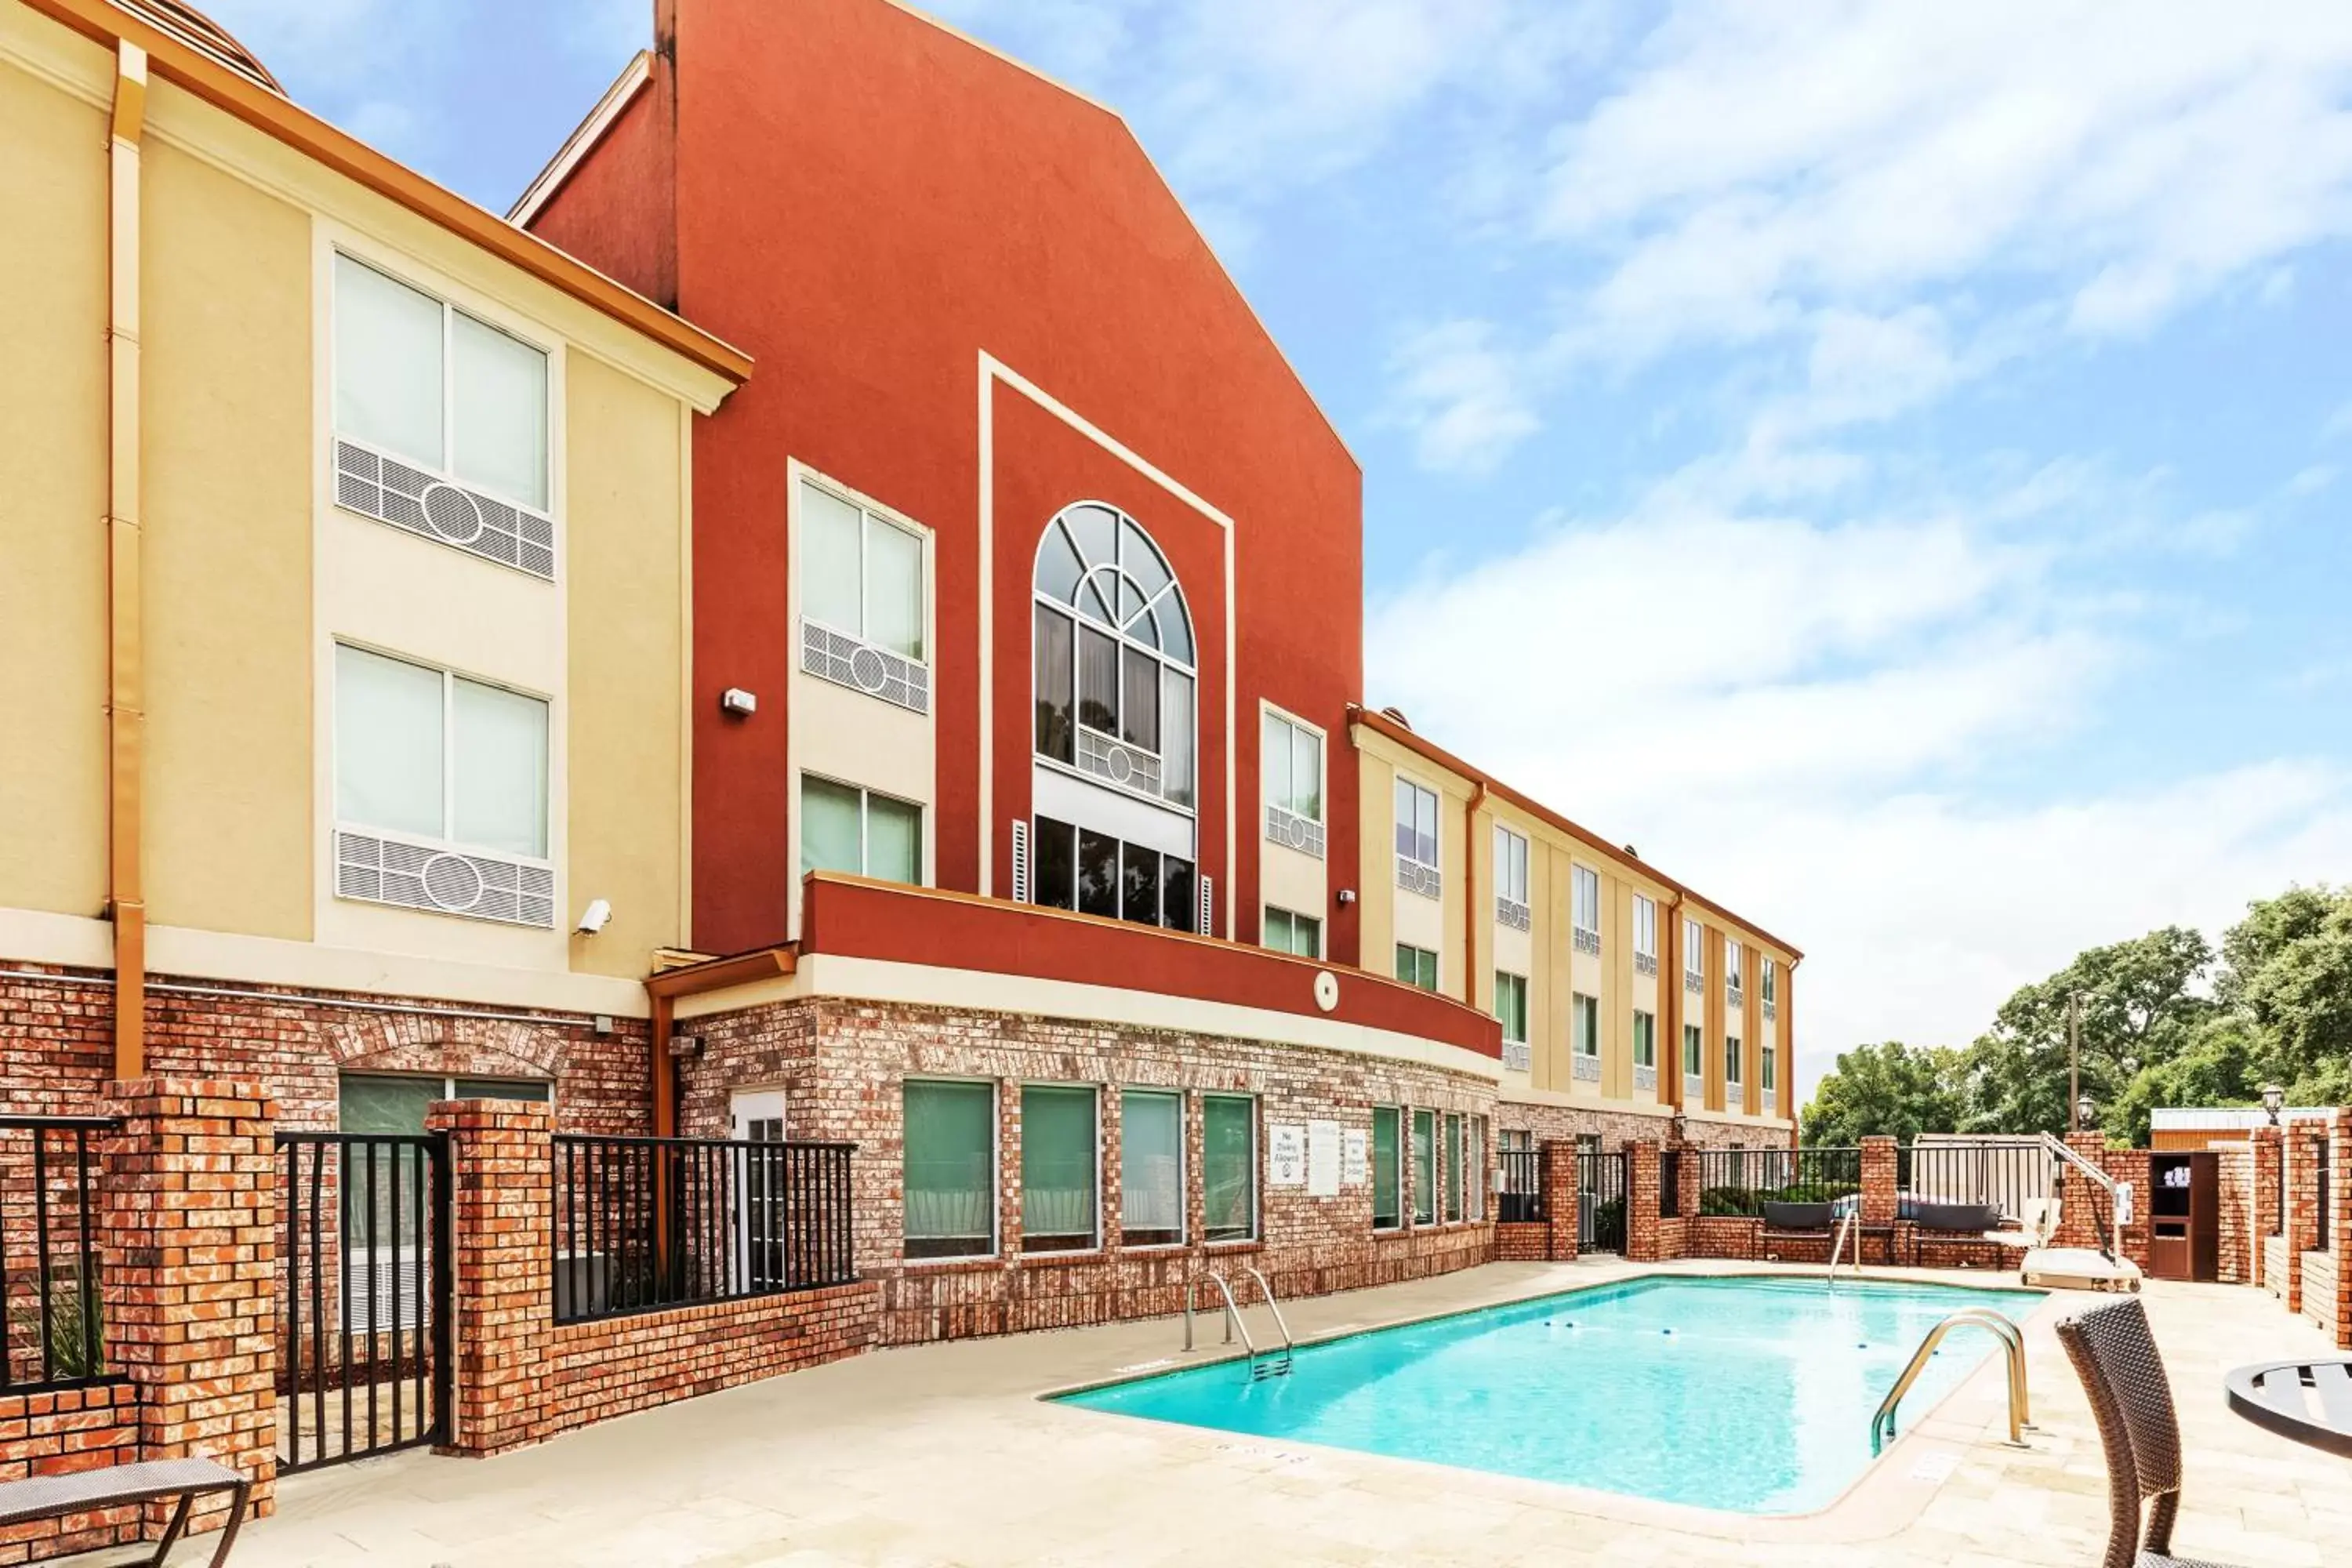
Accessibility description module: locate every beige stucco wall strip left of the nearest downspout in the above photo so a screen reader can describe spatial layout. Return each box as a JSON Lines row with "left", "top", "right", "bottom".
{"left": 0, "top": 49, "right": 106, "bottom": 916}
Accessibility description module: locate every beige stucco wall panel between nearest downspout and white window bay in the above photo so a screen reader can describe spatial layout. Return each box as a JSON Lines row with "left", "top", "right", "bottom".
{"left": 141, "top": 139, "right": 313, "bottom": 940}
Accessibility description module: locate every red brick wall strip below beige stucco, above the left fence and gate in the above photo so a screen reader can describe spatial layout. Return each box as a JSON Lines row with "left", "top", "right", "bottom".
{"left": 0, "top": 968, "right": 652, "bottom": 1135}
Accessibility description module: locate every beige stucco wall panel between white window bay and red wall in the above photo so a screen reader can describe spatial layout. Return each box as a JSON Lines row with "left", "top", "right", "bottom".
{"left": 564, "top": 353, "right": 687, "bottom": 975}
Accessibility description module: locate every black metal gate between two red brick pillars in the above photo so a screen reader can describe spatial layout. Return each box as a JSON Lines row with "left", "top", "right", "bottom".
{"left": 278, "top": 1133, "right": 454, "bottom": 1472}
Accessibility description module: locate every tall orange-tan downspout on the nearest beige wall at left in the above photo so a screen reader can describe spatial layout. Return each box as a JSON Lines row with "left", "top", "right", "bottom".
{"left": 106, "top": 40, "right": 146, "bottom": 1079}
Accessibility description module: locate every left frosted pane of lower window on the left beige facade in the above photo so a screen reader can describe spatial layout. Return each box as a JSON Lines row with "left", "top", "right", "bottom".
{"left": 334, "top": 647, "right": 442, "bottom": 839}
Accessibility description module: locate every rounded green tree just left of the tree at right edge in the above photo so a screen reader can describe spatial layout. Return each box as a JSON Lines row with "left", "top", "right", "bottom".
{"left": 1964, "top": 926, "right": 2216, "bottom": 1133}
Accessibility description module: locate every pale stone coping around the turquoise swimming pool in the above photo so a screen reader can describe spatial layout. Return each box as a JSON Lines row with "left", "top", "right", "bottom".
{"left": 1030, "top": 1258, "right": 2096, "bottom": 1544}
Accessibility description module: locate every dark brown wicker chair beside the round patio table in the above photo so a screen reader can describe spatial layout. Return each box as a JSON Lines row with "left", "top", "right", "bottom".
{"left": 2058, "top": 1298, "right": 2223, "bottom": 1568}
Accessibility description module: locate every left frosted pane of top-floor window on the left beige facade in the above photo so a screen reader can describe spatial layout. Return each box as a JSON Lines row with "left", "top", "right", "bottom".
{"left": 334, "top": 256, "right": 442, "bottom": 468}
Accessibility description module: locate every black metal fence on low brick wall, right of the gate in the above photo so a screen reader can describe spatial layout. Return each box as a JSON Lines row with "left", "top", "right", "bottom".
{"left": 553, "top": 1133, "right": 856, "bottom": 1323}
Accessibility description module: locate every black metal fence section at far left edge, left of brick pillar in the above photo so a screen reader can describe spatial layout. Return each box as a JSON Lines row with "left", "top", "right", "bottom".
{"left": 0, "top": 1116, "right": 118, "bottom": 1394}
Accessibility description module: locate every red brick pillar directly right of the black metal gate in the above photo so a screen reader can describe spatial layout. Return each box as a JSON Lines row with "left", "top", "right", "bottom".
{"left": 426, "top": 1100, "right": 555, "bottom": 1455}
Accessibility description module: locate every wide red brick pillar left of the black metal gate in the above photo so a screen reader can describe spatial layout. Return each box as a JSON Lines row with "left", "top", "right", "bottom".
{"left": 99, "top": 1079, "right": 278, "bottom": 1535}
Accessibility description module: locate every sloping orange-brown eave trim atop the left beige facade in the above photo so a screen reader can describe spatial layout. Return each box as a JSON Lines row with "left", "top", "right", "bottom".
{"left": 24, "top": 0, "right": 753, "bottom": 383}
